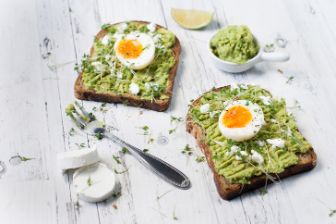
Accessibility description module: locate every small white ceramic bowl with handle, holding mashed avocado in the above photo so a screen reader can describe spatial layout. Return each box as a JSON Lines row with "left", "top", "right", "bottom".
{"left": 207, "top": 31, "right": 289, "bottom": 73}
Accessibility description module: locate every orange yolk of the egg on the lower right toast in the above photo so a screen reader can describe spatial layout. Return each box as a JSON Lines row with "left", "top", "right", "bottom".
{"left": 222, "top": 105, "right": 252, "bottom": 128}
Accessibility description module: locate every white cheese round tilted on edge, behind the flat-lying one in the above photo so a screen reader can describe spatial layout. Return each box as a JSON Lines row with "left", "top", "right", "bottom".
{"left": 57, "top": 148, "right": 99, "bottom": 171}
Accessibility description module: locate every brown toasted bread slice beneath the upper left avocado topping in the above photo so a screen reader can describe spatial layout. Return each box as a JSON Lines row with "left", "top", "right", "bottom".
{"left": 74, "top": 21, "right": 181, "bottom": 111}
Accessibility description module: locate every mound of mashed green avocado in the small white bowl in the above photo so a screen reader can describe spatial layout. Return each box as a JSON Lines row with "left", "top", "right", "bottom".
{"left": 210, "top": 26, "right": 259, "bottom": 64}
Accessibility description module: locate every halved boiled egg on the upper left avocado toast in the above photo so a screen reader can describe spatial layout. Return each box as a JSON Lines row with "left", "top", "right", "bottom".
{"left": 114, "top": 33, "right": 155, "bottom": 70}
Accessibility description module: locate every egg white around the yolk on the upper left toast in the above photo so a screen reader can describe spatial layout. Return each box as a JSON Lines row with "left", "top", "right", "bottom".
{"left": 114, "top": 33, "right": 155, "bottom": 70}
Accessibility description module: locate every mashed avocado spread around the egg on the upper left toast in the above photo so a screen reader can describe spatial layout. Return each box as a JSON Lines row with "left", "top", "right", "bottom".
{"left": 81, "top": 22, "right": 175, "bottom": 100}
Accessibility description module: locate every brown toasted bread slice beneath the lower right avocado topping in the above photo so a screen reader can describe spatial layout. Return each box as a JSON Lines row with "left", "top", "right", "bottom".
{"left": 186, "top": 86, "right": 317, "bottom": 200}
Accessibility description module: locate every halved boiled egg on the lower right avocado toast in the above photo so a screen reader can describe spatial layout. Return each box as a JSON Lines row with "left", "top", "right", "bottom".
{"left": 218, "top": 100, "right": 265, "bottom": 142}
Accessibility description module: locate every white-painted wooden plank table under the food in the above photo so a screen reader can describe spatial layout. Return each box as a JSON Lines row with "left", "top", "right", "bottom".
{"left": 0, "top": 0, "right": 336, "bottom": 224}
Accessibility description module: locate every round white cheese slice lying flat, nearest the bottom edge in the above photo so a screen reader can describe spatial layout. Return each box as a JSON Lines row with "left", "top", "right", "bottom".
{"left": 73, "top": 163, "right": 116, "bottom": 202}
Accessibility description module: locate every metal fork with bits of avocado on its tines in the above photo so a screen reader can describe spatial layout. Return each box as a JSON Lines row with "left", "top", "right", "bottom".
{"left": 66, "top": 101, "right": 191, "bottom": 189}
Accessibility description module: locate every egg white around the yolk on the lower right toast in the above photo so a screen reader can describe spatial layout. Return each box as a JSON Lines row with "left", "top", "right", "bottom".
{"left": 218, "top": 100, "right": 265, "bottom": 142}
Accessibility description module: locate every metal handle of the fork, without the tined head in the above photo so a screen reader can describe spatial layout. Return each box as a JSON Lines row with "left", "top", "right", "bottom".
{"left": 104, "top": 132, "right": 191, "bottom": 189}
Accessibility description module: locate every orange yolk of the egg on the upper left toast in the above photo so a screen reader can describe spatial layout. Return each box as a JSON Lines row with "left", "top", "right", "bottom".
{"left": 117, "top": 39, "right": 143, "bottom": 59}
